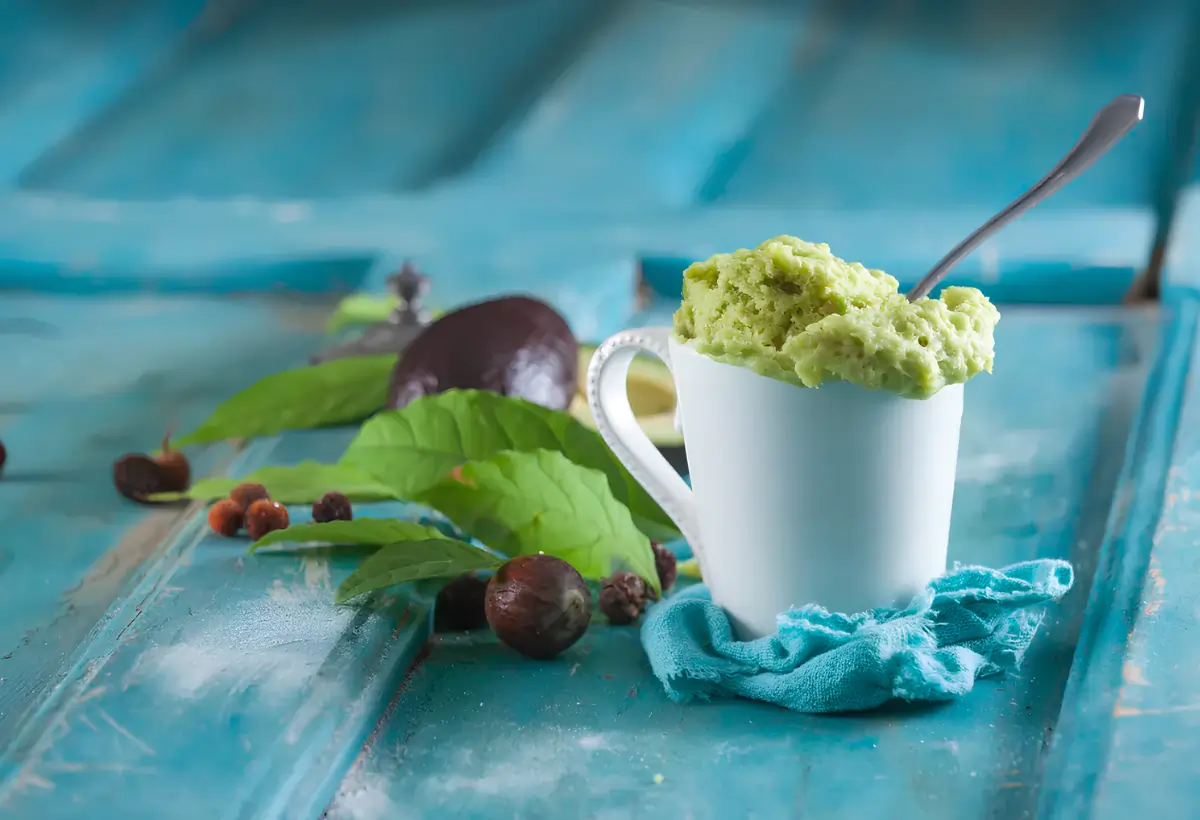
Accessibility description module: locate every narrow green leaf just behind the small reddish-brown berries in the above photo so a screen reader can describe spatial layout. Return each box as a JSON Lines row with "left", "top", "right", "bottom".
{"left": 150, "top": 461, "right": 396, "bottom": 504}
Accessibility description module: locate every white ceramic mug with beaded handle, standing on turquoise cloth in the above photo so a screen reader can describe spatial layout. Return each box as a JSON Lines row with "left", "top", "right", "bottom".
{"left": 587, "top": 328, "right": 962, "bottom": 638}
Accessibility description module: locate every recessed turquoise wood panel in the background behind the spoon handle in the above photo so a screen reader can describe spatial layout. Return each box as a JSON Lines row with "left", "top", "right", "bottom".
{"left": 718, "top": 0, "right": 1196, "bottom": 210}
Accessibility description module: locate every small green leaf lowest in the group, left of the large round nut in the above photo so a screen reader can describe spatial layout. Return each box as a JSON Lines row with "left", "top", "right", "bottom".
{"left": 335, "top": 538, "right": 502, "bottom": 604}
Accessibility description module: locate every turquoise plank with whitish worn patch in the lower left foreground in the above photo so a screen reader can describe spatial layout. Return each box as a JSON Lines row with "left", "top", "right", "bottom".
{"left": 0, "top": 431, "right": 430, "bottom": 818}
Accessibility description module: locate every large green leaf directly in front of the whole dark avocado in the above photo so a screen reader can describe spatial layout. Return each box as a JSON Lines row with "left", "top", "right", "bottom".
{"left": 342, "top": 390, "right": 679, "bottom": 540}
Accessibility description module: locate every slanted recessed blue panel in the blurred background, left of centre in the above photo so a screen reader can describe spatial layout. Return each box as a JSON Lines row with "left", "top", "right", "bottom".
{"left": 22, "top": 0, "right": 602, "bottom": 199}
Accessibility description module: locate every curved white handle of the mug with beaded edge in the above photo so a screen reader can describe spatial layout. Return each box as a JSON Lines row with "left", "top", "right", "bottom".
{"left": 587, "top": 328, "right": 704, "bottom": 574}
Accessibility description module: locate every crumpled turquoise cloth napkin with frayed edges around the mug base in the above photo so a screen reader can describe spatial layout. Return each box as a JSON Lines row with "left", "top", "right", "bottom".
{"left": 642, "top": 559, "right": 1074, "bottom": 712}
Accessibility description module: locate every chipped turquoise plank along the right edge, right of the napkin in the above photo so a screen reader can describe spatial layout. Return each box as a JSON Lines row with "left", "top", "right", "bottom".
{"left": 1039, "top": 219, "right": 1200, "bottom": 818}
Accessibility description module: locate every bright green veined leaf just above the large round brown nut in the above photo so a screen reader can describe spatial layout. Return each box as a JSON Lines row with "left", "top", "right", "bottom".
{"left": 420, "top": 450, "right": 661, "bottom": 593}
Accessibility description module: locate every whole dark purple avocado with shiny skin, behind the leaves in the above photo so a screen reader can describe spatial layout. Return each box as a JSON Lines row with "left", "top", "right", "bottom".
{"left": 388, "top": 297, "right": 580, "bottom": 411}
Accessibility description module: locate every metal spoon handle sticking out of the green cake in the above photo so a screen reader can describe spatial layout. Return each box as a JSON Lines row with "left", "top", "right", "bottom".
{"left": 908, "top": 94, "right": 1146, "bottom": 301}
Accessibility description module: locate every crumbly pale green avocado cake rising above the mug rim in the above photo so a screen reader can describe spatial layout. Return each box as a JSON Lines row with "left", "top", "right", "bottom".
{"left": 674, "top": 237, "right": 1000, "bottom": 399}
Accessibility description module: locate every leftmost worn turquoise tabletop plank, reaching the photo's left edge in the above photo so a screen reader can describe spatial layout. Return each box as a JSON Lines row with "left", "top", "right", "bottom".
{"left": 0, "top": 295, "right": 340, "bottom": 746}
